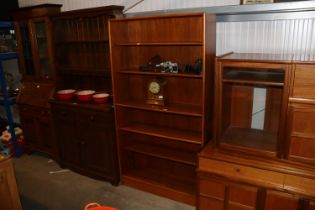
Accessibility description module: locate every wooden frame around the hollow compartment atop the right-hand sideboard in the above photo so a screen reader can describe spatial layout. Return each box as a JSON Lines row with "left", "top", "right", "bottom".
{"left": 215, "top": 54, "right": 291, "bottom": 157}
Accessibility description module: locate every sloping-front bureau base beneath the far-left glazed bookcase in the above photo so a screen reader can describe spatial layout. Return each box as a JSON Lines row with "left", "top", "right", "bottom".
{"left": 17, "top": 82, "right": 57, "bottom": 158}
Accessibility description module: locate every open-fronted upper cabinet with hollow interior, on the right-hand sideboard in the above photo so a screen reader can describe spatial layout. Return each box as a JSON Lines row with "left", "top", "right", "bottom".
{"left": 215, "top": 54, "right": 290, "bottom": 157}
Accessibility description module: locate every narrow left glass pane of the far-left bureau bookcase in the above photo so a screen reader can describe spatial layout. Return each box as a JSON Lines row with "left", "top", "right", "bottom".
{"left": 19, "top": 23, "right": 35, "bottom": 76}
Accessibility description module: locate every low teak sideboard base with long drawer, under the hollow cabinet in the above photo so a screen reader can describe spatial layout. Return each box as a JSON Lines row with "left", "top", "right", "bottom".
{"left": 197, "top": 145, "right": 315, "bottom": 210}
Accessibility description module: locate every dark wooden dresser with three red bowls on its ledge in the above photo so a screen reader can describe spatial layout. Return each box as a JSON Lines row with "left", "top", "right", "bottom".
{"left": 50, "top": 6, "right": 123, "bottom": 185}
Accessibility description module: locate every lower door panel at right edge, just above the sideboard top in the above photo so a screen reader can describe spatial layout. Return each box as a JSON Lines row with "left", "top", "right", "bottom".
{"left": 289, "top": 136, "right": 315, "bottom": 163}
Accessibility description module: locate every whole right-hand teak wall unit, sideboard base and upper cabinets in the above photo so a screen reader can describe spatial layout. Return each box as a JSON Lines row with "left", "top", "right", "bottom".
{"left": 197, "top": 53, "right": 315, "bottom": 210}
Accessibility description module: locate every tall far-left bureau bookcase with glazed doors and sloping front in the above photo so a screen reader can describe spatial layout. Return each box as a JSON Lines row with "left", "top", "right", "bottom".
{"left": 13, "top": 4, "right": 61, "bottom": 157}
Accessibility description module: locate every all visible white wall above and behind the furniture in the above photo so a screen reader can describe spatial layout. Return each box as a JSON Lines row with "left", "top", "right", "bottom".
{"left": 19, "top": 0, "right": 315, "bottom": 55}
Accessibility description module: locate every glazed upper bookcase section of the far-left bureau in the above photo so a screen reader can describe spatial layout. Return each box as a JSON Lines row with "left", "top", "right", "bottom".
{"left": 13, "top": 4, "right": 61, "bottom": 81}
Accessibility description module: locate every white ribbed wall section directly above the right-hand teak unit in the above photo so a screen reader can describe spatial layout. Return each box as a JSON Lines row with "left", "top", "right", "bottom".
{"left": 217, "top": 17, "right": 315, "bottom": 55}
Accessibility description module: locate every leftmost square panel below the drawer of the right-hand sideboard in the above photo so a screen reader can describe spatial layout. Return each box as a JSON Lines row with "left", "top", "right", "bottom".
{"left": 199, "top": 179, "right": 225, "bottom": 199}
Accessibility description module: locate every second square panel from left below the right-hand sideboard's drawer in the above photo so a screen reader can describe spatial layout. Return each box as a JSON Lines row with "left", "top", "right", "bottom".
{"left": 229, "top": 185, "right": 257, "bottom": 208}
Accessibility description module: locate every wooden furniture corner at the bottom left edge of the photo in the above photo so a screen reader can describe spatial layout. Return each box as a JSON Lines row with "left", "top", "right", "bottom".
{"left": 0, "top": 155, "right": 22, "bottom": 210}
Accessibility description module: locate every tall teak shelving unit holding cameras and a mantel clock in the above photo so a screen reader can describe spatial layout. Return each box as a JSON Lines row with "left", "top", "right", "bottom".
{"left": 109, "top": 13, "right": 215, "bottom": 204}
